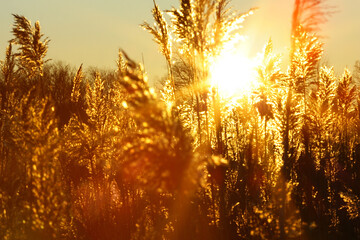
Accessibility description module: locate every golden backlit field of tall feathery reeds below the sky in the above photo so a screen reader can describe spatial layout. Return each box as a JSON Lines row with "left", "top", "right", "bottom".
{"left": 0, "top": 0, "right": 360, "bottom": 240}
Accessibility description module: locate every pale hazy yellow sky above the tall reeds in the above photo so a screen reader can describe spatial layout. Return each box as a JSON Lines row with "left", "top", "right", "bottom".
{"left": 0, "top": 0, "right": 360, "bottom": 81}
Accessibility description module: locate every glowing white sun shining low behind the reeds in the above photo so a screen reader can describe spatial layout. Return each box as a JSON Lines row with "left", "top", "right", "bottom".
{"left": 210, "top": 51, "right": 256, "bottom": 98}
